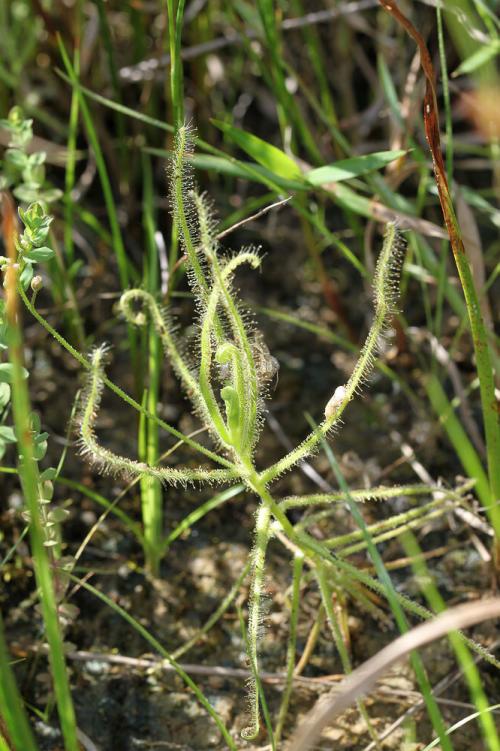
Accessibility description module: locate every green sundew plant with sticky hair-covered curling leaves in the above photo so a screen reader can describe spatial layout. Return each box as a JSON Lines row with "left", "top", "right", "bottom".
{"left": 73, "top": 126, "right": 442, "bottom": 739}
